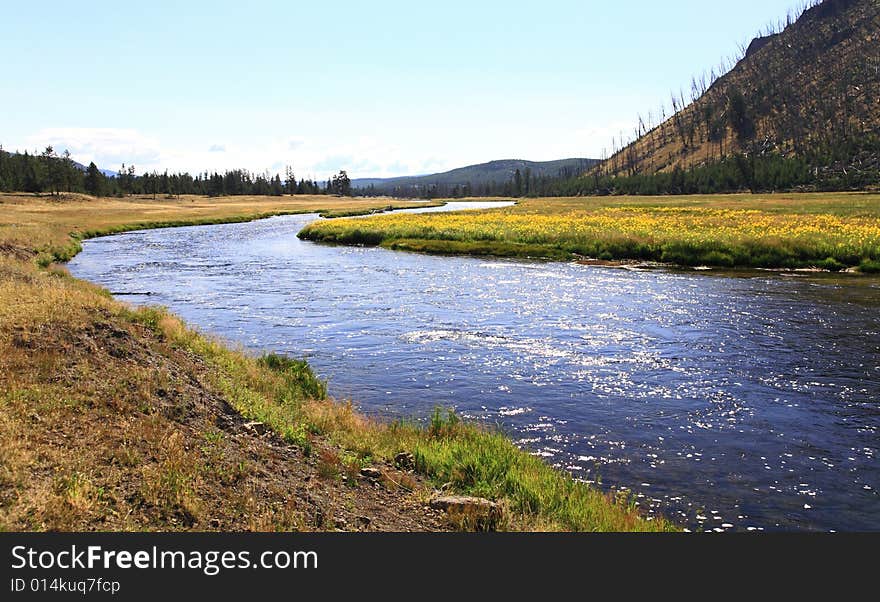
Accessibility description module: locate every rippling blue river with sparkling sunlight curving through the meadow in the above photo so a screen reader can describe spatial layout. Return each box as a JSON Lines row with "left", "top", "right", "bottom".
{"left": 69, "top": 205, "right": 880, "bottom": 531}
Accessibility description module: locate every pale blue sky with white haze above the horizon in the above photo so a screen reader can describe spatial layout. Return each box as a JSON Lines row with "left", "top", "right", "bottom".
{"left": 0, "top": 0, "right": 797, "bottom": 179}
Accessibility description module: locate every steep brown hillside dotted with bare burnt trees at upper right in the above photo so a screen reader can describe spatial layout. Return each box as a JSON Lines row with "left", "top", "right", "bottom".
{"left": 558, "top": 0, "right": 880, "bottom": 194}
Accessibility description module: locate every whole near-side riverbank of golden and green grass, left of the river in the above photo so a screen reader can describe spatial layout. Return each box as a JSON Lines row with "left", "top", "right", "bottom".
{"left": 0, "top": 195, "right": 674, "bottom": 531}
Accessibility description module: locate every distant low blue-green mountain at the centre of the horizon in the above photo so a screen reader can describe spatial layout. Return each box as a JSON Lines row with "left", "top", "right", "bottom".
{"left": 351, "top": 158, "right": 598, "bottom": 196}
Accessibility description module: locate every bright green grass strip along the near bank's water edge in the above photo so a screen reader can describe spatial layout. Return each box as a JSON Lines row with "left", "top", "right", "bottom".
{"left": 127, "top": 308, "right": 676, "bottom": 531}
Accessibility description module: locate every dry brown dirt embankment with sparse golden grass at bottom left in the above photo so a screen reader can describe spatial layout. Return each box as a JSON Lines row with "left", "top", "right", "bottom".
{"left": 0, "top": 296, "right": 444, "bottom": 531}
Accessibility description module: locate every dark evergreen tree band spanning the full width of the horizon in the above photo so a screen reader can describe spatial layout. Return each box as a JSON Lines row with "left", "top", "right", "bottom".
{"left": 0, "top": 135, "right": 880, "bottom": 199}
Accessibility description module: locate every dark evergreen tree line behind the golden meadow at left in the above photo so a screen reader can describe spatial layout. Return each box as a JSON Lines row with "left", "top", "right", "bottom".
{"left": 0, "top": 146, "right": 352, "bottom": 198}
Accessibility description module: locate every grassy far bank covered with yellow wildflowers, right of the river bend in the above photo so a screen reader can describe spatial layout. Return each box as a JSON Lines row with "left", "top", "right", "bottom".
{"left": 300, "top": 193, "right": 880, "bottom": 272}
